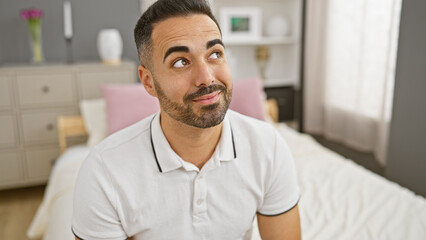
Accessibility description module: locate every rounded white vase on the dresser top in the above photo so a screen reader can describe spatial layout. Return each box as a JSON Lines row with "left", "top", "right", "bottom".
{"left": 98, "top": 29, "right": 123, "bottom": 65}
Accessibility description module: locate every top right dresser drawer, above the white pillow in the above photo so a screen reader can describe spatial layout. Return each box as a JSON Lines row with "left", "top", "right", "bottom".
{"left": 78, "top": 71, "right": 132, "bottom": 99}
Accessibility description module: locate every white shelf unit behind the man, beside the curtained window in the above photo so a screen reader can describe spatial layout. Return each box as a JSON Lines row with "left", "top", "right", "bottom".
{"left": 213, "top": 0, "right": 303, "bottom": 90}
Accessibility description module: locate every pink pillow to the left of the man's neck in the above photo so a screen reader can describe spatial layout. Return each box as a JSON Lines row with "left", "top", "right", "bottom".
{"left": 102, "top": 84, "right": 160, "bottom": 134}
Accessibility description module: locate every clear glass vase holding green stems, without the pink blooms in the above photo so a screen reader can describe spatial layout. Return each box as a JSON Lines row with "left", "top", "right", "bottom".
{"left": 28, "top": 21, "right": 44, "bottom": 64}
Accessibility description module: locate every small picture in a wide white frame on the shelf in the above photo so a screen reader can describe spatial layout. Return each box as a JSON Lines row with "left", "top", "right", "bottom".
{"left": 220, "top": 7, "right": 262, "bottom": 41}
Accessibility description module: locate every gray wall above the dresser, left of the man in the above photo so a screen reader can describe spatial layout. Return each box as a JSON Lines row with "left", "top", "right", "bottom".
{"left": 0, "top": 0, "right": 140, "bottom": 64}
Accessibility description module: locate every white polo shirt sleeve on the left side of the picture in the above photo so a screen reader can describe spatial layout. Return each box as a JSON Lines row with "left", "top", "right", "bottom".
{"left": 71, "top": 149, "right": 127, "bottom": 240}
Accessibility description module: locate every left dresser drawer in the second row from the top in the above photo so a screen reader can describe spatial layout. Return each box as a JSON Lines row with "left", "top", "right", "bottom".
{"left": 21, "top": 110, "right": 76, "bottom": 143}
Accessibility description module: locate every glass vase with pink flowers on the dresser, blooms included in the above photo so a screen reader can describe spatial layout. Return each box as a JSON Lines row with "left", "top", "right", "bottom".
{"left": 21, "top": 8, "right": 44, "bottom": 63}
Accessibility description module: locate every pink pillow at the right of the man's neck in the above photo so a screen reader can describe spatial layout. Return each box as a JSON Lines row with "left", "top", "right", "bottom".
{"left": 229, "top": 78, "right": 265, "bottom": 120}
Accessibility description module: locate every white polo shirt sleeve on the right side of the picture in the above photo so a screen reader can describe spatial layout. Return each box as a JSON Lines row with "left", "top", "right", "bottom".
{"left": 258, "top": 131, "right": 300, "bottom": 216}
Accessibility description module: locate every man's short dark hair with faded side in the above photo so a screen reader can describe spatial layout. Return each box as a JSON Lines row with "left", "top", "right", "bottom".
{"left": 134, "top": 0, "right": 222, "bottom": 70}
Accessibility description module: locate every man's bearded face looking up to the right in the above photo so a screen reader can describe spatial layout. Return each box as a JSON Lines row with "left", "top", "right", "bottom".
{"left": 151, "top": 14, "right": 232, "bottom": 128}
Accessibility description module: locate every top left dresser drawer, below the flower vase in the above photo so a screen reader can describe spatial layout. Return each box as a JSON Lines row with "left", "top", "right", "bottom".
{"left": 17, "top": 73, "right": 75, "bottom": 106}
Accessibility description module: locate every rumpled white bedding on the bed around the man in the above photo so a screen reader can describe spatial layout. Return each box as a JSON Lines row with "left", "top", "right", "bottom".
{"left": 28, "top": 124, "right": 426, "bottom": 240}
